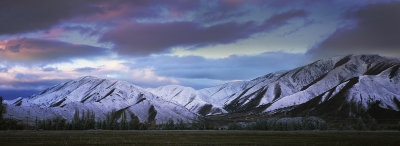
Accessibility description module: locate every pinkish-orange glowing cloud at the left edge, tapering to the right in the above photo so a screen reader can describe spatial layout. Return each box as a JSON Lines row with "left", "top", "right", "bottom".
{"left": 0, "top": 38, "right": 108, "bottom": 63}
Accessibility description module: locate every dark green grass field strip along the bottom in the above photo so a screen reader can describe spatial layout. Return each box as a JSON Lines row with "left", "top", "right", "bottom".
{"left": 0, "top": 130, "right": 400, "bottom": 146}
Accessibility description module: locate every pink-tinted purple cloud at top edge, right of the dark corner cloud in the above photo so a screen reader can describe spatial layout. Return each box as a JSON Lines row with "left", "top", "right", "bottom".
{"left": 71, "top": 0, "right": 201, "bottom": 24}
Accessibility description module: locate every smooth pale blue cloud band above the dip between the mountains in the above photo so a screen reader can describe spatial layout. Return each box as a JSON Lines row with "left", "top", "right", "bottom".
{"left": 131, "top": 52, "right": 307, "bottom": 81}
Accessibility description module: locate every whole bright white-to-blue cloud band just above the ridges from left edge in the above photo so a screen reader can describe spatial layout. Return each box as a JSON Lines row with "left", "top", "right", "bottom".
{"left": 0, "top": 52, "right": 307, "bottom": 93}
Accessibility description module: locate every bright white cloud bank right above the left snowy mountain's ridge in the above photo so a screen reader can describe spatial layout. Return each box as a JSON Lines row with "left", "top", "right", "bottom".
{"left": 0, "top": 60, "right": 179, "bottom": 90}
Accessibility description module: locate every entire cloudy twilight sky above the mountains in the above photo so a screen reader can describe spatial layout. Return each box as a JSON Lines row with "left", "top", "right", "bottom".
{"left": 0, "top": 0, "right": 400, "bottom": 99}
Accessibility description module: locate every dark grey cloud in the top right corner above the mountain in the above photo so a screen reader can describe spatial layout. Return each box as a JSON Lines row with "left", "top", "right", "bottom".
{"left": 308, "top": 2, "right": 400, "bottom": 57}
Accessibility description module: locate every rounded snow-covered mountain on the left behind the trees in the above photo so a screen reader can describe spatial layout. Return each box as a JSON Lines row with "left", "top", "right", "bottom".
{"left": 5, "top": 76, "right": 196, "bottom": 123}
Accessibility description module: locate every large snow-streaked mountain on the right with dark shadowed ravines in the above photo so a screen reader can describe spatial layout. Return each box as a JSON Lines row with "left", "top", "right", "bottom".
{"left": 199, "top": 55, "right": 400, "bottom": 118}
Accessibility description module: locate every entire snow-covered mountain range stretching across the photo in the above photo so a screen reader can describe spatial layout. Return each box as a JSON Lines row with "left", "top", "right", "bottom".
{"left": 5, "top": 55, "right": 400, "bottom": 123}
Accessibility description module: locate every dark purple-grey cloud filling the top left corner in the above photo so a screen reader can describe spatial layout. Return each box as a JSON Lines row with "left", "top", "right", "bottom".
{"left": 0, "top": 0, "right": 101, "bottom": 35}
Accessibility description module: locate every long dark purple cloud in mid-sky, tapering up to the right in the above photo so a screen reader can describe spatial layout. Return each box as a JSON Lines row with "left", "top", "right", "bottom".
{"left": 100, "top": 11, "right": 306, "bottom": 55}
